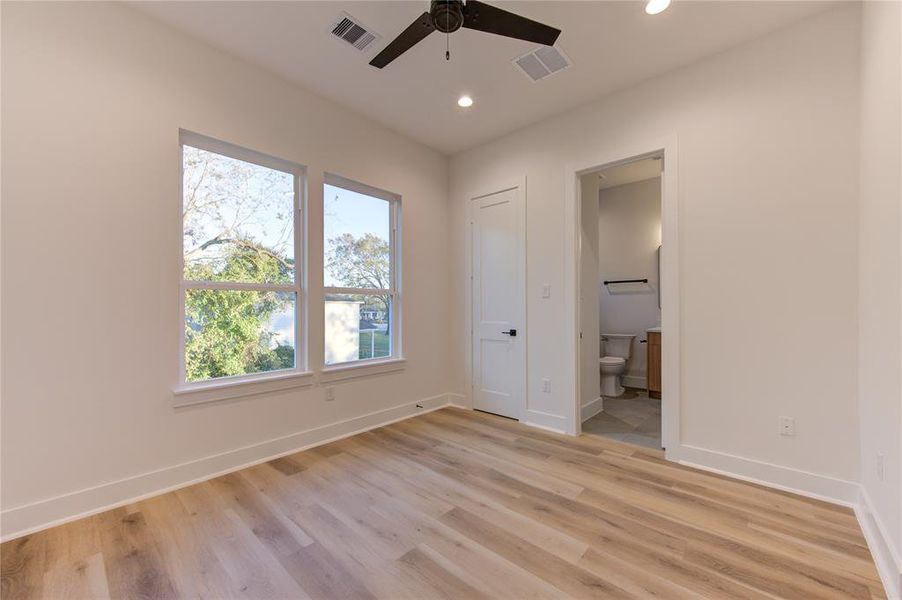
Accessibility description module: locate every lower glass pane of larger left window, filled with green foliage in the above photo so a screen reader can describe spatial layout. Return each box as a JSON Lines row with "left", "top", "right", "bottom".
{"left": 185, "top": 289, "right": 297, "bottom": 381}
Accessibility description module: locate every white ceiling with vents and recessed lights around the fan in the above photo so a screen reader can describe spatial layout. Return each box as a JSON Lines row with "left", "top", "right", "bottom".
{"left": 133, "top": 0, "right": 829, "bottom": 154}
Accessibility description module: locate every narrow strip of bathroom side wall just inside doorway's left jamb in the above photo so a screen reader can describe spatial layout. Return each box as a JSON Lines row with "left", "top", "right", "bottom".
{"left": 579, "top": 173, "right": 603, "bottom": 419}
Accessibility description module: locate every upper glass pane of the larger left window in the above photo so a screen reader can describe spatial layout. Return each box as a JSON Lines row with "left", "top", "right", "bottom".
{"left": 182, "top": 146, "right": 294, "bottom": 284}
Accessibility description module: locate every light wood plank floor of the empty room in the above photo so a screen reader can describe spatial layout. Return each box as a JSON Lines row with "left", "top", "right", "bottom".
{"left": 0, "top": 409, "right": 883, "bottom": 600}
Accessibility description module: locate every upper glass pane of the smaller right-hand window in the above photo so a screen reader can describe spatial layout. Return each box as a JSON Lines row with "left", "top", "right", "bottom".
{"left": 323, "top": 184, "right": 391, "bottom": 289}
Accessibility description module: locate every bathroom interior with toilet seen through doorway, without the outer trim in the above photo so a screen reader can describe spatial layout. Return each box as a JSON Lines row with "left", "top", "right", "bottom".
{"left": 580, "top": 156, "right": 663, "bottom": 450}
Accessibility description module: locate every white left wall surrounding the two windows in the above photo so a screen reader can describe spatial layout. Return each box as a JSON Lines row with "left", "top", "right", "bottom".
{"left": 0, "top": 3, "right": 457, "bottom": 534}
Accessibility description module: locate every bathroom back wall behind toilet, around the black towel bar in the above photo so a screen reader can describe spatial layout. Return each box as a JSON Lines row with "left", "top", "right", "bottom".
{"left": 598, "top": 177, "right": 661, "bottom": 388}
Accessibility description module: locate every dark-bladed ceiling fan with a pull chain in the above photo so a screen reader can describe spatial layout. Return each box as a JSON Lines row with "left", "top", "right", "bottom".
{"left": 370, "top": 0, "right": 561, "bottom": 69}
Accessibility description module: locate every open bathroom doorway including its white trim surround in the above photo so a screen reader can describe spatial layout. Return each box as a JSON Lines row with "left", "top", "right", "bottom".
{"left": 567, "top": 138, "right": 679, "bottom": 459}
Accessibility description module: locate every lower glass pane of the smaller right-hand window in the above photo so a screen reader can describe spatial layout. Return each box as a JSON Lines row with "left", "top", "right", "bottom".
{"left": 325, "top": 294, "right": 391, "bottom": 365}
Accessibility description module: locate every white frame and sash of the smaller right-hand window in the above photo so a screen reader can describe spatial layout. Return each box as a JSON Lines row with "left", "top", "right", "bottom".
{"left": 320, "top": 173, "right": 405, "bottom": 372}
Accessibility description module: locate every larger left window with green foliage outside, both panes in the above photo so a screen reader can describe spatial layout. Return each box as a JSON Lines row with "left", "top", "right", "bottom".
{"left": 180, "top": 131, "right": 306, "bottom": 387}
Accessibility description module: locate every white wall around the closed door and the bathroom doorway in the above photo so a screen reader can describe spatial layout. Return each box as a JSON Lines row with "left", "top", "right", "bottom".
{"left": 451, "top": 5, "right": 859, "bottom": 492}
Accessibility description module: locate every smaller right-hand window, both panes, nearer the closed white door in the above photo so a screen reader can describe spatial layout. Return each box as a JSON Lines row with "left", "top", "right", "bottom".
{"left": 323, "top": 174, "right": 401, "bottom": 366}
